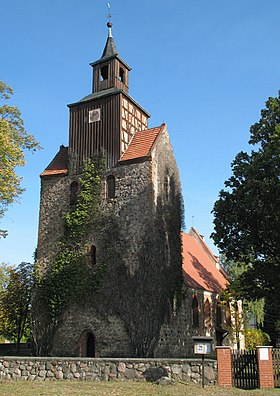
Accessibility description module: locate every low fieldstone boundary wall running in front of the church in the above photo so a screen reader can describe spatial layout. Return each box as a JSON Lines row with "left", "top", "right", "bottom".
{"left": 0, "top": 356, "right": 217, "bottom": 385}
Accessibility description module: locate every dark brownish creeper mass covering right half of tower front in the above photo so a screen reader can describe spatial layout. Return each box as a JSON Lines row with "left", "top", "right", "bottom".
{"left": 111, "top": 181, "right": 183, "bottom": 358}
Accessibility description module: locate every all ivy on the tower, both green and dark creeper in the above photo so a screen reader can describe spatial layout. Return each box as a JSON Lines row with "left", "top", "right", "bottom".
{"left": 34, "top": 154, "right": 183, "bottom": 357}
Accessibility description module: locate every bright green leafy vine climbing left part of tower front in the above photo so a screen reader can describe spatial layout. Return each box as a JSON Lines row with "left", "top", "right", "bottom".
{"left": 39, "top": 158, "right": 106, "bottom": 322}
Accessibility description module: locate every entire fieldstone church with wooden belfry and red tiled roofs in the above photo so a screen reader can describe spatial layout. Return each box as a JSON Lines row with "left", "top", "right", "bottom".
{"left": 32, "top": 22, "right": 230, "bottom": 357}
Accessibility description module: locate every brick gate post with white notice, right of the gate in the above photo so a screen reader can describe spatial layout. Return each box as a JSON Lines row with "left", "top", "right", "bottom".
{"left": 257, "top": 346, "right": 274, "bottom": 389}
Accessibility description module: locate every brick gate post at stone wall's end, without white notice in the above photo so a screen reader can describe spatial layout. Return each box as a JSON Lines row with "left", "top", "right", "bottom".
{"left": 216, "top": 346, "right": 232, "bottom": 388}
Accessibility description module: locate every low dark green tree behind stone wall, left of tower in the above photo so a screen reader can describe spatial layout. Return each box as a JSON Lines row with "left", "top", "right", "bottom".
{"left": 0, "top": 262, "right": 33, "bottom": 347}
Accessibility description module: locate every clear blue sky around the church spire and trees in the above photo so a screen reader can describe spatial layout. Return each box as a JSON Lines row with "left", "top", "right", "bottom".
{"left": 0, "top": 0, "right": 280, "bottom": 264}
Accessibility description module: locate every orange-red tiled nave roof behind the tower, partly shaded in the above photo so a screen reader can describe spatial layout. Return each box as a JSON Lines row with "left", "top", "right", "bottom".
{"left": 182, "top": 228, "right": 228, "bottom": 293}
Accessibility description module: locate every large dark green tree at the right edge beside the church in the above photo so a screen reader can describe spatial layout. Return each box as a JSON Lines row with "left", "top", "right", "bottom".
{"left": 212, "top": 94, "right": 280, "bottom": 344}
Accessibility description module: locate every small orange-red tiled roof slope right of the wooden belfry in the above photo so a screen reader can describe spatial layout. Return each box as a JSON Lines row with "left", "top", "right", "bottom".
{"left": 120, "top": 124, "right": 165, "bottom": 161}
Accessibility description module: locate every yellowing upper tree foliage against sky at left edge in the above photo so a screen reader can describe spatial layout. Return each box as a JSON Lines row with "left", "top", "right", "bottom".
{"left": 0, "top": 81, "right": 39, "bottom": 236}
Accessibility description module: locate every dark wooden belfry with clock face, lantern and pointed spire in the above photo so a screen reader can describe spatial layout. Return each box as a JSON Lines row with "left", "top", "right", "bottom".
{"left": 68, "top": 22, "right": 149, "bottom": 172}
